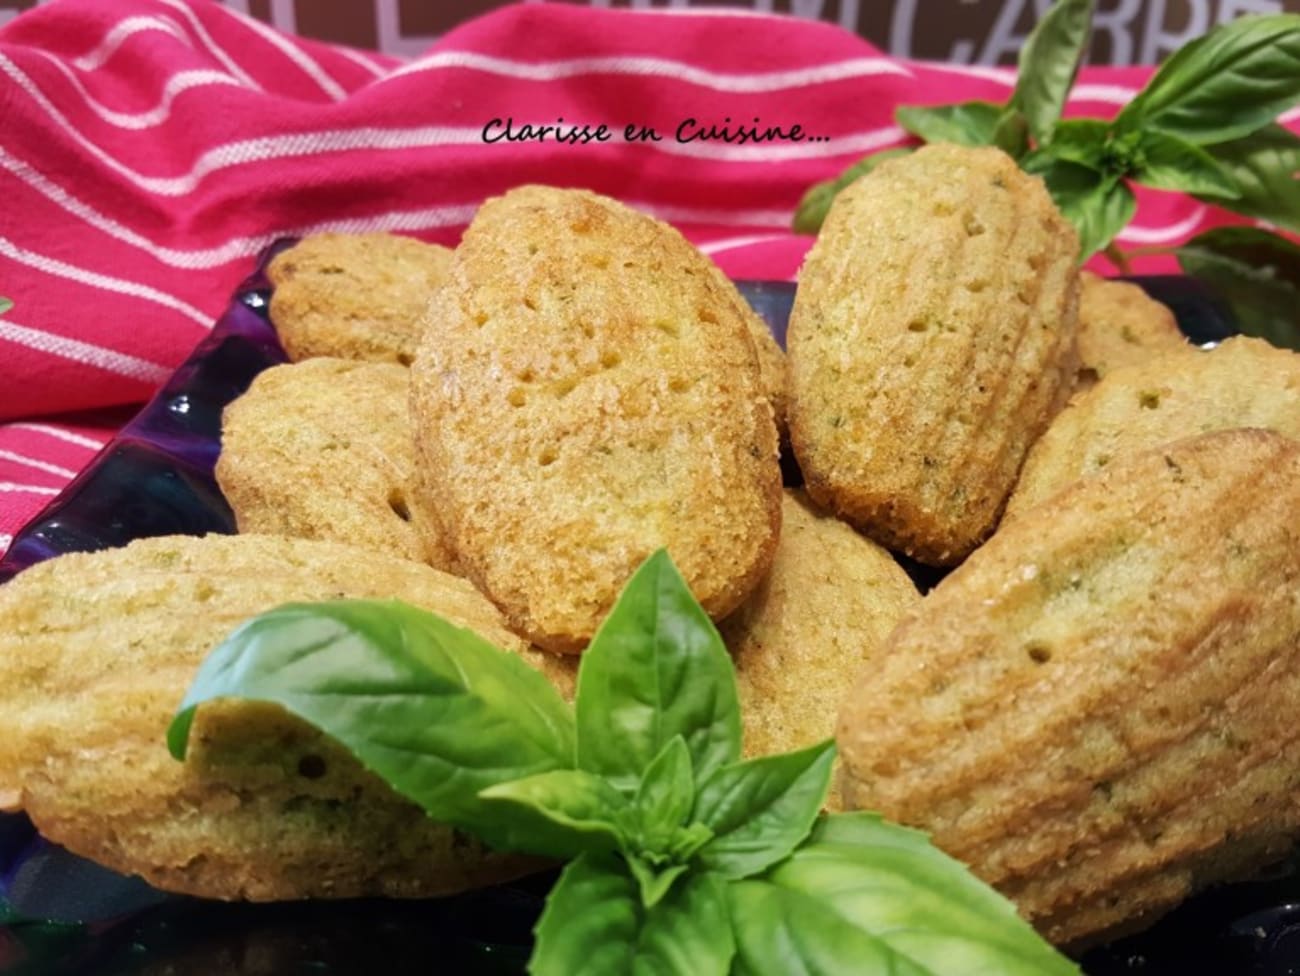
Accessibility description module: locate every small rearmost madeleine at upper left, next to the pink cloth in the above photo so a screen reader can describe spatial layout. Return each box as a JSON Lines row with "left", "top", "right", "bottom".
{"left": 267, "top": 233, "right": 451, "bottom": 365}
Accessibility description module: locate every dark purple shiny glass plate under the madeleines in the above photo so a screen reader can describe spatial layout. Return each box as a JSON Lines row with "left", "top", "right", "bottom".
{"left": 0, "top": 261, "right": 1300, "bottom": 976}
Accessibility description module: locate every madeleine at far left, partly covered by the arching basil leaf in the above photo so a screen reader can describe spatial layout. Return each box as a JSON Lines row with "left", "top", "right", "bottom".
{"left": 0, "top": 535, "right": 568, "bottom": 901}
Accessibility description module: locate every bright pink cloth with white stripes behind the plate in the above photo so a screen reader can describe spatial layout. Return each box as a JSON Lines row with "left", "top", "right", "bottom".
{"left": 0, "top": 0, "right": 1237, "bottom": 552}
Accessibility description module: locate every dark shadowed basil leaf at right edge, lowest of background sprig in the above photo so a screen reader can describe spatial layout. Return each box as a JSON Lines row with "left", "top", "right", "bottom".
{"left": 1175, "top": 227, "right": 1300, "bottom": 351}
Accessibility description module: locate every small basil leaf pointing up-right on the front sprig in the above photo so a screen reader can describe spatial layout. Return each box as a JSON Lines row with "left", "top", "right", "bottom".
{"left": 696, "top": 739, "right": 835, "bottom": 879}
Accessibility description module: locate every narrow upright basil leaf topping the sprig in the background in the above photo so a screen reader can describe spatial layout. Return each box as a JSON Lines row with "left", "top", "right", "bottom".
{"left": 1010, "top": 0, "right": 1092, "bottom": 144}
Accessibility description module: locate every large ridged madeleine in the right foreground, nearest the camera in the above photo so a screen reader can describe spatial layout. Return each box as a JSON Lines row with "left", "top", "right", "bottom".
{"left": 839, "top": 430, "right": 1300, "bottom": 942}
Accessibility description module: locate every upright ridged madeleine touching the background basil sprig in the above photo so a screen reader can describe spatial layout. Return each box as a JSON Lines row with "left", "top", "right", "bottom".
{"left": 788, "top": 146, "right": 1079, "bottom": 565}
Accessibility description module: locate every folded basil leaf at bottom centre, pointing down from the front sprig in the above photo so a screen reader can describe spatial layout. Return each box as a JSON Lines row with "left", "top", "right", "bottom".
{"left": 529, "top": 854, "right": 736, "bottom": 976}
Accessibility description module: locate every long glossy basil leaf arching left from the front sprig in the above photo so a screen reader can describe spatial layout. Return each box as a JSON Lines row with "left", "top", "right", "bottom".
{"left": 168, "top": 600, "right": 573, "bottom": 847}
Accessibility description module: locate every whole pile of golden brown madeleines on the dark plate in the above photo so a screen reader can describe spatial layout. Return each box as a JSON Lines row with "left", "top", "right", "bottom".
{"left": 0, "top": 146, "right": 1300, "bottom": 944}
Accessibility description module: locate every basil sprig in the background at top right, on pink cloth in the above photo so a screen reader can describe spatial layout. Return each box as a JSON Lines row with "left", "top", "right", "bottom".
{"left": 794, "top": 0, "right": 1300, "bottom": 348}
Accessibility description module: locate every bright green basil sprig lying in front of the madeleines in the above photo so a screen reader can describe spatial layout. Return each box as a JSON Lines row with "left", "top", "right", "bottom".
{"left": 168, "top": 551, "right": 1078, "bottom": 976}
